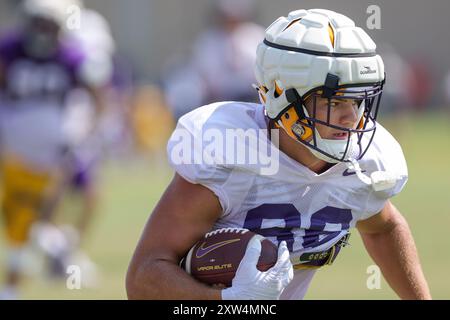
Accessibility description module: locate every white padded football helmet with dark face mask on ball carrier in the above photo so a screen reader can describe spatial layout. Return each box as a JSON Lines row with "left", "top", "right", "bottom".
{"left": 255, "top": 9, "right": 385, "bottom": 163}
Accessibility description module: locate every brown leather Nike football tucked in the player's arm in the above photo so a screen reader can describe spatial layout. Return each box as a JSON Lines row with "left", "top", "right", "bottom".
{"left": 180, "top": 228, "right": 278, "bottom": 287}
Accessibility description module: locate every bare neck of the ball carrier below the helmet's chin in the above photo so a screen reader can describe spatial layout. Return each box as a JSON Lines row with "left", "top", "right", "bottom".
{"left": 279, "top": 130, "right": 332, "bottom": 174}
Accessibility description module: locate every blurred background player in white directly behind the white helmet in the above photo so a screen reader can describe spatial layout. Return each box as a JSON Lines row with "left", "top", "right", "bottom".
{"left": 164, "top": 0, "right": 264, "bottom": 119}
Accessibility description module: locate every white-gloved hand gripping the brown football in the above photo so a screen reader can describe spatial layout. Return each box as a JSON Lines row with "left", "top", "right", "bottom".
{"left": 222, "top": 237, "right": 294, "bottom": 300}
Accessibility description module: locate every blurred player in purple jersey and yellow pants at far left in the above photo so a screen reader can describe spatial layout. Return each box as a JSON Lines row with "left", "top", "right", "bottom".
{"left": 0, "top": 0, "right": 109, "bottom": 298}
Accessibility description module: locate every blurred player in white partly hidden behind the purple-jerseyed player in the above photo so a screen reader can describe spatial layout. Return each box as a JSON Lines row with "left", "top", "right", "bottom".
{"left": 63, "top": 3, "right": 118, "bottom": 255}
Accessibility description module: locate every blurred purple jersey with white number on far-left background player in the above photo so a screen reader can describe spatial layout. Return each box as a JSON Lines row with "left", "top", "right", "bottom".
{"left": 0, "top": 34, "right": 85, "bottom": 102}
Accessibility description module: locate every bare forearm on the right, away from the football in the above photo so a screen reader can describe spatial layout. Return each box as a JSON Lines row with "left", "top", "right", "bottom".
{"left": 361, "top": 217, "right": 431, "bottom": 299}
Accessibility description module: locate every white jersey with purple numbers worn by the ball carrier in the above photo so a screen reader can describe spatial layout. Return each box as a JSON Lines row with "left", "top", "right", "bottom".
{"left": 167, "top": 102, "right": 408, "bottom": 300}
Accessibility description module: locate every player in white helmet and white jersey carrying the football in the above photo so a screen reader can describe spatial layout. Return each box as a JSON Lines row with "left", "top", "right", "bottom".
{"left": 127, "top": 9, "right": 431, "bottom": 299}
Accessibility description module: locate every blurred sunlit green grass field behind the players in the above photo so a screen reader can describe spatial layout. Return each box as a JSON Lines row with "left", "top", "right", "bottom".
{"left": 0, "top": 114, "right": 450, "bottom": 299}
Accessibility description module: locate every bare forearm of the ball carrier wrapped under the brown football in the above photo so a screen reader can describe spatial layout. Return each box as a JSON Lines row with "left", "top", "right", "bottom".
{"left": 127, "top": 260, "right": 221, "bottom": 300}
